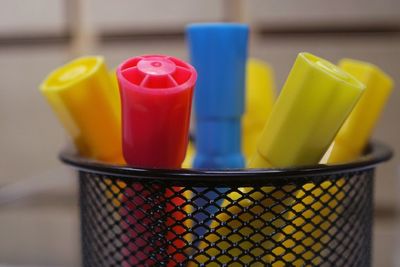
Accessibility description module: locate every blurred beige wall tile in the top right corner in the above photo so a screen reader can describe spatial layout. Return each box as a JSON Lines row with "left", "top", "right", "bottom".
{"left": 244, "top": 0, "right": 400, "bottom": 29}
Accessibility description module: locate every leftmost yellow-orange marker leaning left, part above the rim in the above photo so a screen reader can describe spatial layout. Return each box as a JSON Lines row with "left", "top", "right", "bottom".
{"left": 40, "top": 56, "right": 124, "bottom": 163}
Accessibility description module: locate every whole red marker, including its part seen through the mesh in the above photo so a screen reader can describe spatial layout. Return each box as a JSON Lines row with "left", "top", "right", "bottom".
{"left": 117, "top": 55, "right": 197, "bottom": 266}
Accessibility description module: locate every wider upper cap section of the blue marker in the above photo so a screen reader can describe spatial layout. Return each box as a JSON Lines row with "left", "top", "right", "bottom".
{"left": 186, "top": 23, "right": 249, "bottom": 120}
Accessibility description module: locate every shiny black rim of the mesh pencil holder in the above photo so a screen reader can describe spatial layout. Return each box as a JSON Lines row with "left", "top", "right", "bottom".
{"left": 59, "top": 141, "right": 393, "bottom": 183}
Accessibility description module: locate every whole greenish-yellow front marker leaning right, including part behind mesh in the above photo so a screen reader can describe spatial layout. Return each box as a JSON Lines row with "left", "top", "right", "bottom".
{"left": 191, "top": 53, "right": 364, "bottom": 266}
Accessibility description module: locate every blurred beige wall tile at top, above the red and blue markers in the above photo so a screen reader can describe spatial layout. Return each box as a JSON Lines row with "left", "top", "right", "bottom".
{"left": 89, "top": 0, "right": 224, "bottom": 33}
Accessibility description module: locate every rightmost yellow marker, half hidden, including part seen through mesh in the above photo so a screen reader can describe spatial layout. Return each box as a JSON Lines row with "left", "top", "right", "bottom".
{"left": 285, "top": 59, "right": 393, "bottom": 265}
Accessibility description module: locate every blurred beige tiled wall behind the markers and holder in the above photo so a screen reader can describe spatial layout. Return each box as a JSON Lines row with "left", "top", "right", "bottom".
{"left": 0, "top": 0, "right": 400, "bottom": 266}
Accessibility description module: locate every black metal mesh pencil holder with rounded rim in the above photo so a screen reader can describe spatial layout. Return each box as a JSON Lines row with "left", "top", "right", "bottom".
{"left": 60, "top": 142, "right": 392, "bottom": 267}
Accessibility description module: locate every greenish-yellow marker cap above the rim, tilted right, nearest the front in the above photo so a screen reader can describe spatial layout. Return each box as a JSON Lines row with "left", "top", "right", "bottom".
{"left": 249, "top": 53, "right": 364, "bottom": 168}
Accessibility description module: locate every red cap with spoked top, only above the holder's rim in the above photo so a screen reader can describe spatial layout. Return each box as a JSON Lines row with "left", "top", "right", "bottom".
{"left": 117, "top": 55, "right": 197, "bottom": 168}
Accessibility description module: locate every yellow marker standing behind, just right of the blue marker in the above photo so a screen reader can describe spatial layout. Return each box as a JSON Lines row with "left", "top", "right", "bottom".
{"left": 242, "top": 58, "right": 276, "bottom": 159}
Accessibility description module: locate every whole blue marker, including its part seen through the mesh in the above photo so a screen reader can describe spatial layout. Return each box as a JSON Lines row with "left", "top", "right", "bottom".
{"left": 186, "top": 23, "right": 249, "bottom": 244}
